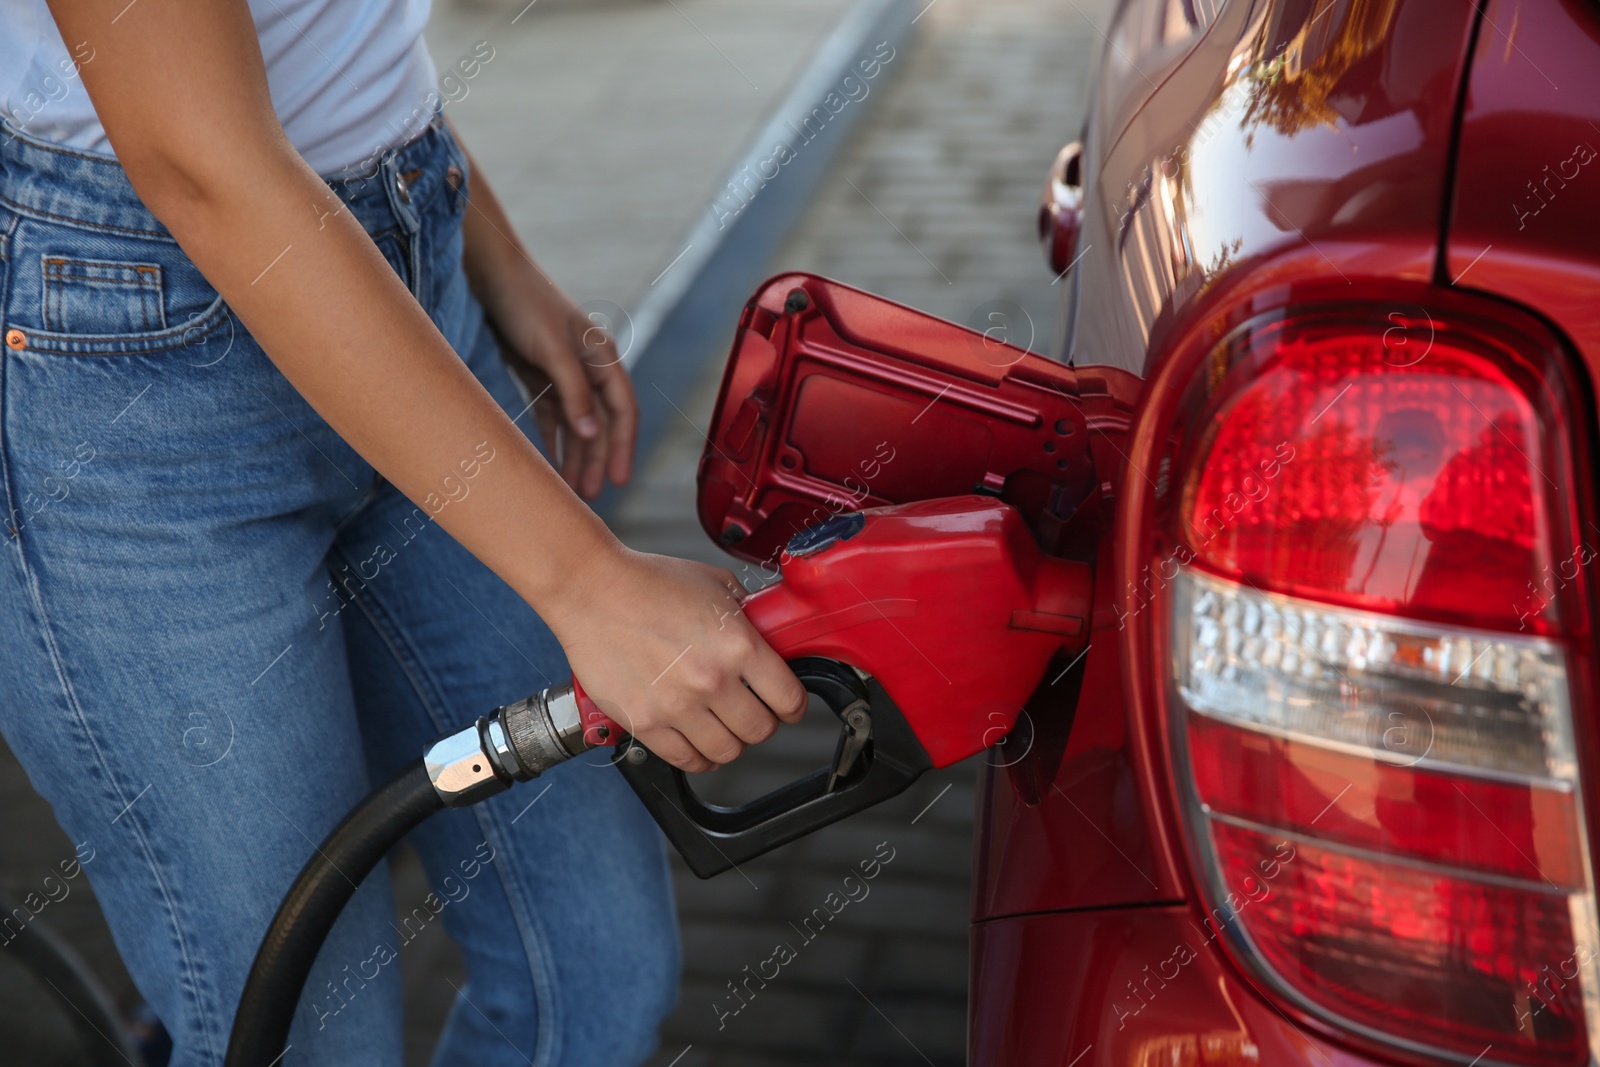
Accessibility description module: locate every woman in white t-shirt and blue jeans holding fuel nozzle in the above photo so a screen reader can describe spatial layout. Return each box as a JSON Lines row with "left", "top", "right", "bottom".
{"left": 0, "top": 0, "right": 803, "bottom": 1067}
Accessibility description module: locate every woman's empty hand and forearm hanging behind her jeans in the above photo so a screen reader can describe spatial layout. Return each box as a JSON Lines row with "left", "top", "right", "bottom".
{"left": 462, "top": 137, "right": 638, "bottom": 499}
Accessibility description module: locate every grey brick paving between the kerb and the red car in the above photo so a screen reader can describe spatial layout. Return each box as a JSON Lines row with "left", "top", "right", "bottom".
{"left": 614, "top": 0, "right": 1109, "bottom": 1067}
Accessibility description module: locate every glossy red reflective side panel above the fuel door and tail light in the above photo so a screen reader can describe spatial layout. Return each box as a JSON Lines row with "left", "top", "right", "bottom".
{"left": 1067, "top": 0, "right": 1472, "bottom": 373}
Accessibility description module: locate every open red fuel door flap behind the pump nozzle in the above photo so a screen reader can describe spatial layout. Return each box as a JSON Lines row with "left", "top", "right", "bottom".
{"left": 699, "top": 274, "right": 1139, "bottom": 565}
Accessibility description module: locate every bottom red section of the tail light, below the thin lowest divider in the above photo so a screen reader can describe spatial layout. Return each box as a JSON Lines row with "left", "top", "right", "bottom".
{"left": 1211, "top": 821, "right": 1589, "bottom": 1064}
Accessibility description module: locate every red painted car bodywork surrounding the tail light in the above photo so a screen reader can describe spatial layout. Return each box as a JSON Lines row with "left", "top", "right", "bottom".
{"left": 970, "top": 0, "right": 1580, "bottom": 1067}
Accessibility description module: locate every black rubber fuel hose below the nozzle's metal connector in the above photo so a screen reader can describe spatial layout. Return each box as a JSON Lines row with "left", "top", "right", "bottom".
{"left": 224, "top": 760, "right": 445, "bottom": 1067}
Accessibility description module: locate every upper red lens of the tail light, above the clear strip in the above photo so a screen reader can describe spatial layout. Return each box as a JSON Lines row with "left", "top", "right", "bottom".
{"left": 1182, "top": 320, "right": 1550, "bottom": 629}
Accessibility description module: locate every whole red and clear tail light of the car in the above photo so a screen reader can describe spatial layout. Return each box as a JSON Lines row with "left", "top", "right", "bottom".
{"left": 1152, "top": 307, "right": 1600, "bottom": 1065}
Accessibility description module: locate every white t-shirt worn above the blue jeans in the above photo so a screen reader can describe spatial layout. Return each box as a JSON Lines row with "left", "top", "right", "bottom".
{"left": 0, "top": 0, "right": 438, "bottom": 176}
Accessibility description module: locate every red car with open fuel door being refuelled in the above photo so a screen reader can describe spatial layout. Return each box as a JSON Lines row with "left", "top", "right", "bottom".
{"left": 684, "top": 0, "right": 1600, "bottom": 1067}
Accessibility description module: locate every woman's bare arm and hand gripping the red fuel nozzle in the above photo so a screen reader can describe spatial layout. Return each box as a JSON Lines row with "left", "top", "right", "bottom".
{"left": 50, "top": 0, "right": 805, "bottom": 769}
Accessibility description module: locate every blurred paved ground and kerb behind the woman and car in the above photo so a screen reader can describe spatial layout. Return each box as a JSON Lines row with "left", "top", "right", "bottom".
{"left": 0, "top": 0, "right": 1112, "bottom": 1067}
